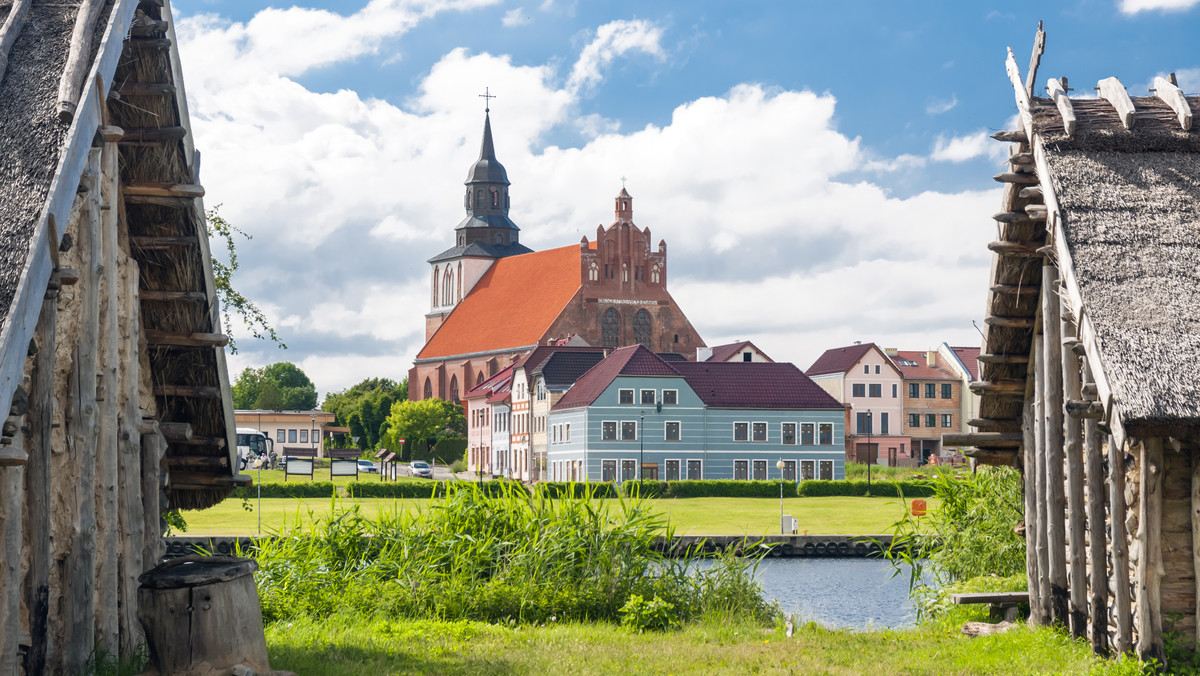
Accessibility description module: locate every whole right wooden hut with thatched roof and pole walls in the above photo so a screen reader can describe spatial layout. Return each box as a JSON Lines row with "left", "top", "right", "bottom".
{"left": 956, "top": 25, "right": 1200, "bottom": 660}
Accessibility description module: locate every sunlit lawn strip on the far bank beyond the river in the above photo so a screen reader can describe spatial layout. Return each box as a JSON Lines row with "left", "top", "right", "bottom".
{"left": 177, "top": 497, "right": 937, "bottom": 536}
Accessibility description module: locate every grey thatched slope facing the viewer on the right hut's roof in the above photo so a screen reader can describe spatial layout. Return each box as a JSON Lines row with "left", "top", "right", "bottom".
{"left": 1034, "top": 97, "right": 1200, "bottom": 426}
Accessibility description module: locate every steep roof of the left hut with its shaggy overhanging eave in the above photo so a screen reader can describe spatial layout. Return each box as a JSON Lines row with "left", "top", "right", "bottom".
{"left": 0, "top": 0, "right": 240, "bottom": 508}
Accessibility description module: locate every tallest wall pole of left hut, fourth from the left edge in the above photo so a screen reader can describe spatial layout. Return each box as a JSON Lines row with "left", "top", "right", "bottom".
{"left": 96, "top": 128, "right": 120, "bottom": 654}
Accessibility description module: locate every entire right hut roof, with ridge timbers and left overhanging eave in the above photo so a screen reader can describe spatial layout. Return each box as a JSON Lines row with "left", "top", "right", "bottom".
{"left": 972, "top": 35, "right": 1200, "bottom": 461}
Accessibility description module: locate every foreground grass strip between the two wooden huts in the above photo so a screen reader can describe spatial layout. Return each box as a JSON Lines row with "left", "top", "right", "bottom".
{"left": 266, "top": 610, "right": 1113, "bottom": 676}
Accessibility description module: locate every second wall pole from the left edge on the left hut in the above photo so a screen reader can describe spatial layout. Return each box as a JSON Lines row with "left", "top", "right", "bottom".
{"left": 25, "top": 289, "right": 59, "bottom": 674}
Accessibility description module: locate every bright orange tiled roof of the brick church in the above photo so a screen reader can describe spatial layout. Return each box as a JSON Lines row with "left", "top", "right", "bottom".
{"left": 416, "top": 244, "right": 582, "bottom": 360}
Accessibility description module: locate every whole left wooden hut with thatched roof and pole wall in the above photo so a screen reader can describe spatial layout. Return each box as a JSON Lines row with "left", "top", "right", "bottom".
{"left": 0, "top": 0, "right": 248, "bottom": 675}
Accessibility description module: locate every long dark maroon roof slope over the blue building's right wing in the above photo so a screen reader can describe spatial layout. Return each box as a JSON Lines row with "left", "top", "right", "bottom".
{"left": 673, "top": 361, "right": 845, "bottom": 409}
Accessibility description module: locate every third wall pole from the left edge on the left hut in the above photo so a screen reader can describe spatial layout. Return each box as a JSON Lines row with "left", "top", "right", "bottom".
{"left": 62, "top": 149, "right": 101, "bottom": 674}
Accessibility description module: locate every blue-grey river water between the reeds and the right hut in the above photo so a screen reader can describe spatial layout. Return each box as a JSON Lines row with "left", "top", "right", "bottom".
{"left": 758, "top": 558, "right": 916, "bottom": 629}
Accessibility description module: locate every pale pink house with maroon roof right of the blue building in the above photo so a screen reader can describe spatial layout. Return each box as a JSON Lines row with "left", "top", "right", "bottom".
{"left": 805, "top": 342, "right": 916, "bottom": 467}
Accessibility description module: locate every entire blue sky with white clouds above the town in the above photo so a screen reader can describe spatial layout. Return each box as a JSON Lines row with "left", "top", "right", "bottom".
{"left": 173, "top": 0, "right": 1200, "bottom": 401}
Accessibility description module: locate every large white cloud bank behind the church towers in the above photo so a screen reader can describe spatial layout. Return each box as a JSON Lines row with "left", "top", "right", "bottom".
{"left": 179, "top": 4, "right": 1003, "bottom": 393}
